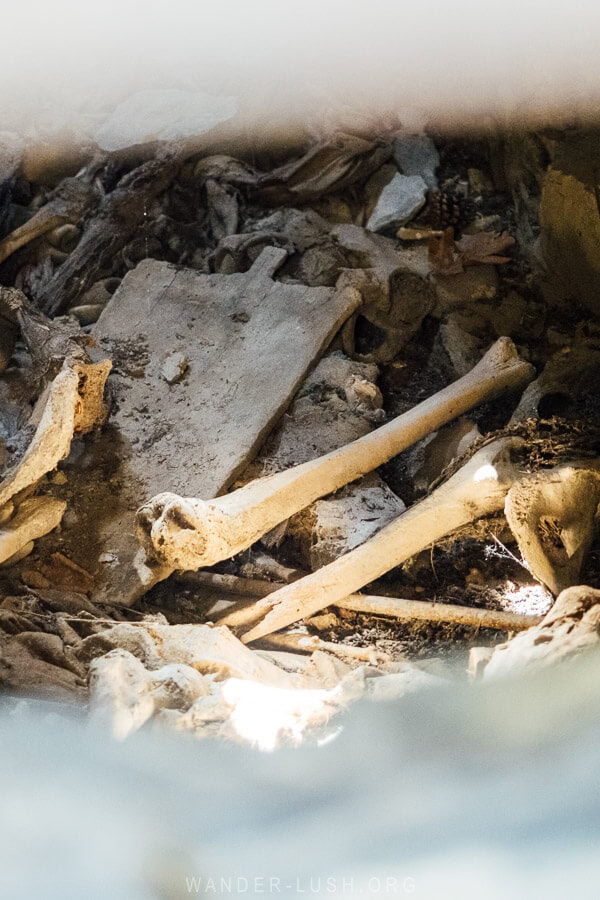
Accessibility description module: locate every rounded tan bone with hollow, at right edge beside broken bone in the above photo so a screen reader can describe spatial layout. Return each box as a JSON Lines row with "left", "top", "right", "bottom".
{"left": 505, "top": 464, "right": 600, "bottom": 595}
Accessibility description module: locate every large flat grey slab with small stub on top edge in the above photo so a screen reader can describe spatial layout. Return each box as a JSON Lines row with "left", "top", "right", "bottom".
{"left": 58, "top": 247, "right": 360, "bottom": 604}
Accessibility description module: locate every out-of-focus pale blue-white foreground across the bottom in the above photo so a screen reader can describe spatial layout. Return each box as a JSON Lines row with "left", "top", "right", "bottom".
{"left": 0, "top": 655, "right": 600, "bottom": 900}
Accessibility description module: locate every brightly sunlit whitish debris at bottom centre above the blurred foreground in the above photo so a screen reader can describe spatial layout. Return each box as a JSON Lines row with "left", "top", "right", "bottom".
{"left": 77, "top": 625, "right": 376, "bottom": 750}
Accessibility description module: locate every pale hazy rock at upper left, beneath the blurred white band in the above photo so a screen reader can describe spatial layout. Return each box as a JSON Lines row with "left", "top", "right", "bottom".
{"left": 95, "top": 88, "right": 236, "bottom": 150}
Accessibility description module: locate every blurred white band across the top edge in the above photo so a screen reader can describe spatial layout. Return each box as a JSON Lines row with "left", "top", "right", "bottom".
{"left": 0, "top": 0, "right": 600, "bottom": 140}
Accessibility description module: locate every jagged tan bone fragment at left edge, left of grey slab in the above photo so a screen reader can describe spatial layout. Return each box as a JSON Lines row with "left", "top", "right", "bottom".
{"left": 0, "top": 360, "right": 111, "bottom": 512}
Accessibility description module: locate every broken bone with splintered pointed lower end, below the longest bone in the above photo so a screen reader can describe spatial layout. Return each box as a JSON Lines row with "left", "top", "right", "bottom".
{"left": 234, "top": 438, "right": 523, "bottom": 643}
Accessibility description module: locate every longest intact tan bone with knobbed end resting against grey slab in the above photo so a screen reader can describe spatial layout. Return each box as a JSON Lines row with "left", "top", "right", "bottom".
{"left": 137, "top": 337, "right": 534, "bottom": 570}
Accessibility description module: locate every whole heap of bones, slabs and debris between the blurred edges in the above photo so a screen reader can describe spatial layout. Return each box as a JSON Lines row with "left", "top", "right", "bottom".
{"left": 0, "top": 123, "right": 600, "bottom": 747}
